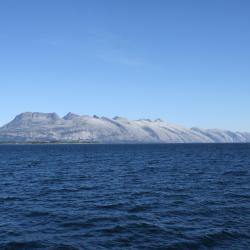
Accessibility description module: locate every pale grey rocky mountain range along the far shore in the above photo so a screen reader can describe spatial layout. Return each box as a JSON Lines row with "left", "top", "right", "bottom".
{"left": 0, "top": 112, "right": 250, "bottom": 143}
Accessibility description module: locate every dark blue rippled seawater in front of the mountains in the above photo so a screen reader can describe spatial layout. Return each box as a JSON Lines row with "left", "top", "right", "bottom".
{"left": 0, "top": 144, "right": 250, "bottom": 250}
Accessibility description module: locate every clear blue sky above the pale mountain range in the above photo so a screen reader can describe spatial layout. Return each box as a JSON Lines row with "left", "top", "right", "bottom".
{"left": 0, "top": 0, "right": 250, "bottom": 131}
